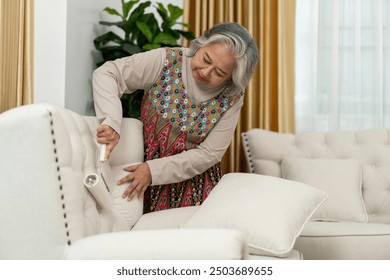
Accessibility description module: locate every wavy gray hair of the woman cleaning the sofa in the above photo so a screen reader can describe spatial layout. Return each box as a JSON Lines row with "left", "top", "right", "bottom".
{"left": 189, "top": 22, "right": 259, "bottom": 95}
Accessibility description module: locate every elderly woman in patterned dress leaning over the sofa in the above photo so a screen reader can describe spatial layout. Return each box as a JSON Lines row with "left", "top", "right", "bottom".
{"left": 93, "top": 23, "right": 258, "bottom": 213}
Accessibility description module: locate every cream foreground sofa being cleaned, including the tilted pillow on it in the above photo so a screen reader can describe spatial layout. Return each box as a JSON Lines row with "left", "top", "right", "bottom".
{"left": 0, "top": 104, "right": 326, "bottom": 259}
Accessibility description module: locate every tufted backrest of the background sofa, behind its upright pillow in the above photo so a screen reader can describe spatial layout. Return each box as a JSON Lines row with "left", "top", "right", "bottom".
{"left": 242, "top": 129, "right": 390, "bottom": 224}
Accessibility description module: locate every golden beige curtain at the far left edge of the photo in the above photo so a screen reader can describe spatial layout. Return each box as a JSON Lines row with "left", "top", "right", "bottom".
{"left": 0, "top": 0, "right": 34, "bottom": 113}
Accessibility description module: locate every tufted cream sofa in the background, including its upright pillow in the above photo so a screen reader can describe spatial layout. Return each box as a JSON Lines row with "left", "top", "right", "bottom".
{"left": 242, "top": 129, "right": 390, "bottom": 260}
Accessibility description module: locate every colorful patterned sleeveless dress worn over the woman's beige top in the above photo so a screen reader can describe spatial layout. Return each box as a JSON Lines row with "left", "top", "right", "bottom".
{"left": 141, "top": 48, "right": 241, "bottom": 213}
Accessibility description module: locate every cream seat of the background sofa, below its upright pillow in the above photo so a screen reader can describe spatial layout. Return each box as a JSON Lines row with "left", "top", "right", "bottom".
{"left": 294, "top": 221, "right": 390, "bottom": 260}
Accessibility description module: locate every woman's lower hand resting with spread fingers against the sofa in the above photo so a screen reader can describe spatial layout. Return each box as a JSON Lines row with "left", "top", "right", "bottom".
{"left": 118, "top": 162, "right": 152, "bottom": 201}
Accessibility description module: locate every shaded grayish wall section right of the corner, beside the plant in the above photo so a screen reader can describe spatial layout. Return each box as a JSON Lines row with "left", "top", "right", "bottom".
{"left": 65, "top": 0, "right": 121, "bottom": 115}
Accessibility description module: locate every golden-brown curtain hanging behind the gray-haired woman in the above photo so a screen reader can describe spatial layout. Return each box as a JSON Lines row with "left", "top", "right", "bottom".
{"left": 184, "top": 0, "right": 295, "bottom": 173}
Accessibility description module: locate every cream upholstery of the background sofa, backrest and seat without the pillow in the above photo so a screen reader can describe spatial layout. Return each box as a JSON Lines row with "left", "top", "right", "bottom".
{"left": 242, "top": 129, "right": 390, "bottom": 260}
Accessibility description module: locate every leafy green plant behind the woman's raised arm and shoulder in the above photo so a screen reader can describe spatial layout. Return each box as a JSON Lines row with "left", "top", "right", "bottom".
{"left": 94, "top": 0, "right": 194, "bottom": 118}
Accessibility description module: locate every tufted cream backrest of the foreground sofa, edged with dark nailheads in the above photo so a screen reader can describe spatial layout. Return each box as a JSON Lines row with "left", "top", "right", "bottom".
{"left": 0, "top": 104, "right": 143, "bottom": 259}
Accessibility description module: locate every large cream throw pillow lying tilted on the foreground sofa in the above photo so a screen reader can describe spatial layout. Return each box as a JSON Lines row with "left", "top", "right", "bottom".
{"left": 181, "top": 173, "right": 327, "bottom": 257}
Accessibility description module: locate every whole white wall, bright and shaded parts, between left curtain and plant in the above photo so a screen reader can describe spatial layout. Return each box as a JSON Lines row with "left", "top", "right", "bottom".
{"left": 34, "top": 0, "right": 183, "bottom": 115}
